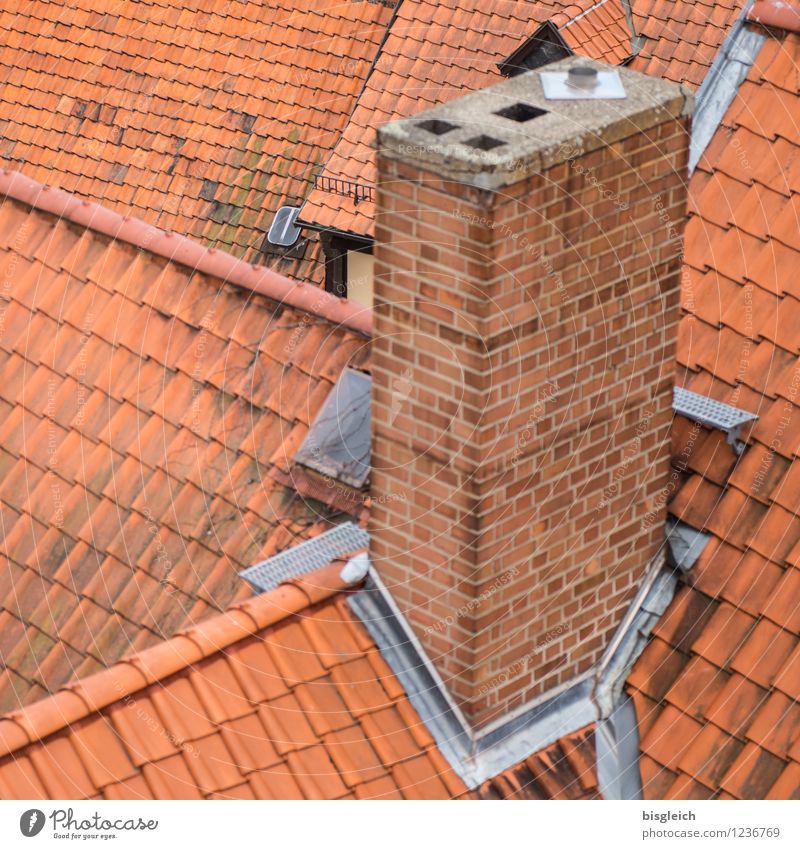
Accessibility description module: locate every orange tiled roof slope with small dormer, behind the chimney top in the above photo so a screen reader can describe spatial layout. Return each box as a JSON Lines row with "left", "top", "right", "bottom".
{"left": 300, "top": 0, "right": 630, "bottom": 236}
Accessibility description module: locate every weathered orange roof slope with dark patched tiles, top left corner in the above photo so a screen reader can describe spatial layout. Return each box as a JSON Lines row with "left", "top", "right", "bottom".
{"left": 0, "top": 0, "right": 391, "bottom": 279}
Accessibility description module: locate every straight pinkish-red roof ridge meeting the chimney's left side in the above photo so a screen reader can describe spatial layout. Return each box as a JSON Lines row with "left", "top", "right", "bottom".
{"left": 0, "top": 169, "right": 372, "bottom": 335}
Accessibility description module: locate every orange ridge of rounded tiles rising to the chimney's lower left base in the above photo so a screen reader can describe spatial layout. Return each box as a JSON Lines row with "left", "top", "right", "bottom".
{"left": 0, "top": 555, "right": 363, "bottom": 758}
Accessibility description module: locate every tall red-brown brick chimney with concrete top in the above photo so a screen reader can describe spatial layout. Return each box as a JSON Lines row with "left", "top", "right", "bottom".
{"left": 370, "top": 57, "right": 691, "bottom": 728}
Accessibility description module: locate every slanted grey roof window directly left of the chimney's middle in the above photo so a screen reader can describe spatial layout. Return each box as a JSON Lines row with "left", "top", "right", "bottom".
{"left": 294, "top": 368, "right": 372, "bottom": 489}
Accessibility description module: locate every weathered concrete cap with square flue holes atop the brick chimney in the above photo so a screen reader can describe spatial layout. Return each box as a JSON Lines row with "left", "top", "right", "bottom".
{"left": 378, "top": 56, "right": 693, "bottom": 189}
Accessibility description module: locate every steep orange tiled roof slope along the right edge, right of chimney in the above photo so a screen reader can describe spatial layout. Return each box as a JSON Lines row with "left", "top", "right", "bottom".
{"left": 629, "top": 34, "right": 800, "bottom": 799}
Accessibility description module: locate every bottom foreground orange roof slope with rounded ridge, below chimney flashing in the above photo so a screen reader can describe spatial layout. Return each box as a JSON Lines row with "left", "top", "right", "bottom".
{"left": 0, "top": 562, "right": 596, "bottom": 799}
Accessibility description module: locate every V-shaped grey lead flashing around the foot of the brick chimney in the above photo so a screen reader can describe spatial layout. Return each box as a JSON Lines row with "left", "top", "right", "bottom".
{"left": 347, "top": 524, "right": 699, "bottom": 788}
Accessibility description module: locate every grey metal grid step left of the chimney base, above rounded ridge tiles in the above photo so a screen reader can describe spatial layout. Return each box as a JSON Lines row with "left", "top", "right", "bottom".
{"left": 241, "top": 522, "right": 369, "bottom": 592}
